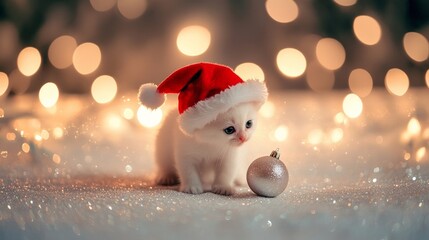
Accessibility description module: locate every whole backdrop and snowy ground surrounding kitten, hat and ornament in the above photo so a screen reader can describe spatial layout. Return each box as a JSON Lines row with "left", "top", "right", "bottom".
{"left": 0, "top": 3, "right": 429, "bottom": 239}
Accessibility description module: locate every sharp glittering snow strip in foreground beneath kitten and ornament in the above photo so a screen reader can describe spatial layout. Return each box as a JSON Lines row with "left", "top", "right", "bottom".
{"left": 0, "top": 177, "right": 429, "bottom": 239}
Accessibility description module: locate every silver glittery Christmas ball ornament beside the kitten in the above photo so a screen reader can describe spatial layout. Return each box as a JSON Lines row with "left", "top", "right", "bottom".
{"left": 247, "top": 149, "right": 289, "bottom": 197}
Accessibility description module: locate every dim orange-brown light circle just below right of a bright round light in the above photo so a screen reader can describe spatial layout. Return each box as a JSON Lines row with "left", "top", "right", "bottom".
{"left": 306, "top": 62, "right": 335, "bottom": 92}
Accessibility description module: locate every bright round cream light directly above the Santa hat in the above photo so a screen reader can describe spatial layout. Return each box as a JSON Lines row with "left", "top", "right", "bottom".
{"left": 176, "top": 26, "right": 211, "bottom": 56}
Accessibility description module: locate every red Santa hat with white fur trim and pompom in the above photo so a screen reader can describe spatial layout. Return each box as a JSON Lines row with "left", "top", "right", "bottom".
{"left": 138, "top": 63, "right": 268, "bottom": 134}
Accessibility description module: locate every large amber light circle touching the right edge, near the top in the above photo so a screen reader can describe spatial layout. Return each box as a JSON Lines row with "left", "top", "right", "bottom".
{"left": 403, "top": 32, "right": 429, "bottom": 62}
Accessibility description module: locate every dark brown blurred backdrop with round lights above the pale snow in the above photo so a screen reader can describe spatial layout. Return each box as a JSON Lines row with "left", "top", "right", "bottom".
{"left": 0, "top": 0, "right": 429, "bottom": 102}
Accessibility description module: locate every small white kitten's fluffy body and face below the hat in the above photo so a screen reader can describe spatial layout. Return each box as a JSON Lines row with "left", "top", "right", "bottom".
{"left": 155, "top": 103, "right": 259, "bottom": 195}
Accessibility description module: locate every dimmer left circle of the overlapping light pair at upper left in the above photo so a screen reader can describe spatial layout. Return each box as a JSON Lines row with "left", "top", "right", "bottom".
{"left": 48, "top": 35, "right": 77, "bottom": 69}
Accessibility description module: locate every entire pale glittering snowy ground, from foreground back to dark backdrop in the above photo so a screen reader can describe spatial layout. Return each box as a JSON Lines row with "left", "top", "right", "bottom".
{"left": 0, "top": 89, "right": 429, "bottom": 240}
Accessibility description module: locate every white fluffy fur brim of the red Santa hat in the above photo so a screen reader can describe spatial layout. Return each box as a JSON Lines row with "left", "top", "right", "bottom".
{"left": 179, "top": 80, "right": 268, "bottom": 134}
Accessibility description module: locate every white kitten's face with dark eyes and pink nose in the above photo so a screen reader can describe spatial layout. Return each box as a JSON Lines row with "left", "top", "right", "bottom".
{"left": 195, "top": 103, "right": 258, "bottom": 146}
